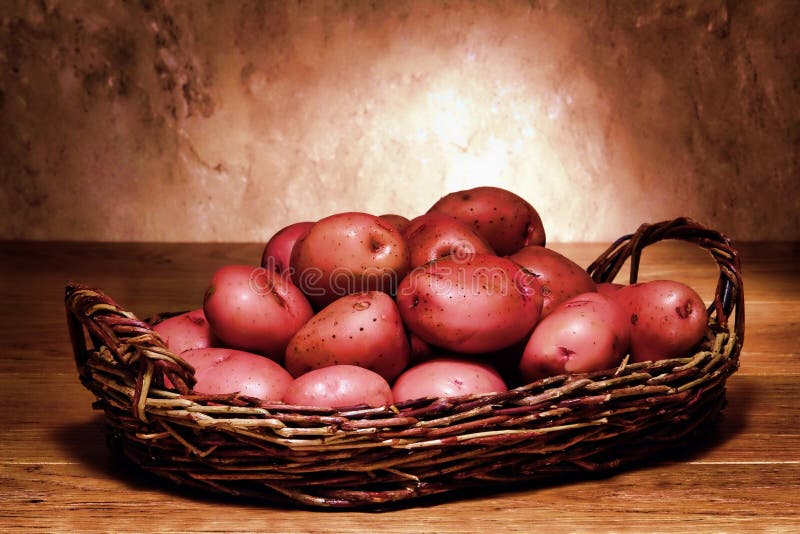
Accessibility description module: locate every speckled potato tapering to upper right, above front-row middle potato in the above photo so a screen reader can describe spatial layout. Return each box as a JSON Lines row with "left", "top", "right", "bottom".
{"left": 285, "top": 291, "right": 409, "bottom": 381}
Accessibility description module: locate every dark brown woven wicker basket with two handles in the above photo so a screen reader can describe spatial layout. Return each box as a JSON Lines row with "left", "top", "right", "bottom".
{"left": 66, "top": 218, "right": 744, "bottom": 508}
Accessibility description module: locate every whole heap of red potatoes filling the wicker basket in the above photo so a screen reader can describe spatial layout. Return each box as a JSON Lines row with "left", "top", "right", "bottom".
{"left": 154, "top": 187, "right": 708, "bottom": 408}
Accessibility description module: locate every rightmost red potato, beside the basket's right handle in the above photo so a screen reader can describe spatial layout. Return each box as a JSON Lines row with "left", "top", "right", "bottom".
{"left": 613, "top": 280, "right": 708, "bottom": 362}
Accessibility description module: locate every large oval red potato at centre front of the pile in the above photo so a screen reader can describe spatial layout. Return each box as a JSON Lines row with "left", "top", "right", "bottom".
{"left": 397, "top": 254, "right": 542, "bottom": 354}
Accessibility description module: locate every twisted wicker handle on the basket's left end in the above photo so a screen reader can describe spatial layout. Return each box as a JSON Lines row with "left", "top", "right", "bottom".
{"left": 64, "top": 283, "right": 196, "bottom": 418}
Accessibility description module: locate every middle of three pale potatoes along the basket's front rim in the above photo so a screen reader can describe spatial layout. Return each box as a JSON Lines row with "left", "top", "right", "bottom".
{"left": 283, "top": 365, "right": 394, "bottom": 408}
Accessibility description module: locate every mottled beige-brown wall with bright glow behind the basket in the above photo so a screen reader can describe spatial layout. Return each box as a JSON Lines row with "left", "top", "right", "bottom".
{"left": 0, "top": 0, "right": 800, "bottom": 241}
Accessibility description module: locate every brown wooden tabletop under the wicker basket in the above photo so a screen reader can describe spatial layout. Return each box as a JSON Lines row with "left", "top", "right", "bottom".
{"left": 0, "top": 242, "right": 800, "bottom": 533}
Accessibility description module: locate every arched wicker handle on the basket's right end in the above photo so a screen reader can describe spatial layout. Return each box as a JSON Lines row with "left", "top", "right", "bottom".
{"left": 586, "top": 217, "right": 744, "bottom": 345}
